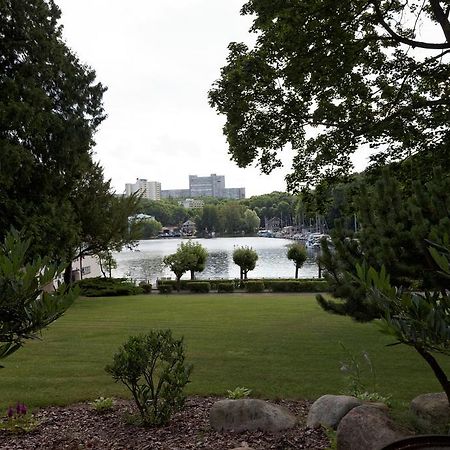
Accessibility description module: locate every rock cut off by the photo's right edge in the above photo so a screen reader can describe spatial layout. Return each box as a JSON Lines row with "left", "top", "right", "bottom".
{"left": 410, "top": 392, "right": 450, "bottom": 427}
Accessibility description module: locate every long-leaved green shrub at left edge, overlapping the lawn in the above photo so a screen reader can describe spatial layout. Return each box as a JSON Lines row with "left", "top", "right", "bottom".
{"left": 0, "top": 230, "right": 77, "bottom": 366}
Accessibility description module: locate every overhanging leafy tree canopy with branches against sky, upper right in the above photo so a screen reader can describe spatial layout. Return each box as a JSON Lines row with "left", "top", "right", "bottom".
{"left": 209, "top": 0, "right": 450, "bottom": 189}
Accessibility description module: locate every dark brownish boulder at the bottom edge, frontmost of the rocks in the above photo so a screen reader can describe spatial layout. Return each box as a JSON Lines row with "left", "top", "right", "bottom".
{"left": 336, "top": 405, "right": 409, "bottom": 450}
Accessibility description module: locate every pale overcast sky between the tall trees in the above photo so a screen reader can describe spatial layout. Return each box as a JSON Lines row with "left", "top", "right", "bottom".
{"left": 56, "top": 0, "right": 298, "bottom": 197}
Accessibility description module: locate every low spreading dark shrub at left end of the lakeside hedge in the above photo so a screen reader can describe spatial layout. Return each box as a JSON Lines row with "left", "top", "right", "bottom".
{"left": 76, "top": 277, "right": 144, "bottom": 297}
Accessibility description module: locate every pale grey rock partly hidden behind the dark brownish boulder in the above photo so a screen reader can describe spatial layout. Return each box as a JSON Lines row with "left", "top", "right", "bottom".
{"left": 306, "top": 395, "right": 362, "bottom": 429}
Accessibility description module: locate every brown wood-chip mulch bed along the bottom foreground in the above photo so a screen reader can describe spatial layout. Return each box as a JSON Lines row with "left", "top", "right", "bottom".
{"left": 0, "top": 397, "right": 329, "bottom": 450}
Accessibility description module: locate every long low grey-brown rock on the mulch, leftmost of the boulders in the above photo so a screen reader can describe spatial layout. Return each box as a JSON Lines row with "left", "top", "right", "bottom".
{"left": 209, "top": 398, "right": 297, "bottom": 432}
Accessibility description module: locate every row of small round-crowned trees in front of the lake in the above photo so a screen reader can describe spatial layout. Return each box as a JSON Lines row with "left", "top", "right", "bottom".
{"left": 163, "top": 241, "right": 307, "bottom": 282}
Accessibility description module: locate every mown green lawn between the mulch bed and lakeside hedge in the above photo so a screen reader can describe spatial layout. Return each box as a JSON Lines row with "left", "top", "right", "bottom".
{"left": 0, "top": 294, "right": 450, "bottom": 410}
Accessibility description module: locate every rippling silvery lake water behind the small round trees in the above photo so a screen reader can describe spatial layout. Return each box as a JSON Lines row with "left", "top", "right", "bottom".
{"left": 113, "top": 237, "right": 318, "bottom": 283}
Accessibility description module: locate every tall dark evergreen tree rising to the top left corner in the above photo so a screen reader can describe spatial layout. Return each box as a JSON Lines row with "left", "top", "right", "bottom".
{"left": 0, "top": 0, "right": 105, "bottom": 260}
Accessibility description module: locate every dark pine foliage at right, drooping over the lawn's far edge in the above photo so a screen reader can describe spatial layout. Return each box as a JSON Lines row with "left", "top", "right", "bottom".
{"left": 318, "top": 169, "right": 450, "bottom": 321}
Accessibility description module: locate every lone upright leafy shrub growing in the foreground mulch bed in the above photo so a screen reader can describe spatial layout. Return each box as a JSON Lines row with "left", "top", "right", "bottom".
{"left": 105, "top": 330, "right": 192, "bottom": 426}
